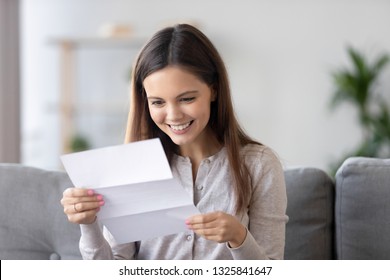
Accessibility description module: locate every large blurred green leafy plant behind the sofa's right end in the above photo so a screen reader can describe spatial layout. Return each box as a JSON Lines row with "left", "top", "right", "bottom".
{"left": 330, "top": 47, "right": 390, "bottom": 175}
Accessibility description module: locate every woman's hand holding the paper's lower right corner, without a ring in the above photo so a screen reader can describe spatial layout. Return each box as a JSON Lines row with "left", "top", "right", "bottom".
{"left": 186, "top": 212, "right": 246, "bottom": 248}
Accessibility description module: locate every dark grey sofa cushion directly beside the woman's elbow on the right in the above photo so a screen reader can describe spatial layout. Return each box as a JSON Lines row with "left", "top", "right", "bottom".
{"left": 284, "top": 168, "right": 334, "bottom": 260}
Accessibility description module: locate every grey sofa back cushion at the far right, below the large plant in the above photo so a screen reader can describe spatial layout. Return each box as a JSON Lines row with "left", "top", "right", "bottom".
{"left": 335, "top": 157, "right": 390, "bottom": 259}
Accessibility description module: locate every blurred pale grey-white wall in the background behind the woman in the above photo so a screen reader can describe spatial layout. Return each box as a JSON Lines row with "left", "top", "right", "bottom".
{"left": 21, "top": 0, "right": 390, "bottom": 169}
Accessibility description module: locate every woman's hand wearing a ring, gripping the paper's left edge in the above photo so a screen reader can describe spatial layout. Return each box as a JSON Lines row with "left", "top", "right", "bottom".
{"left": 61, "top": 188, "right": 104, "bottom": 224}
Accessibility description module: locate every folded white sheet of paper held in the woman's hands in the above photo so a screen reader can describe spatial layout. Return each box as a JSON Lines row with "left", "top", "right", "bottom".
{"left": 61, "top": 139, "right": 199, "bottom": 243}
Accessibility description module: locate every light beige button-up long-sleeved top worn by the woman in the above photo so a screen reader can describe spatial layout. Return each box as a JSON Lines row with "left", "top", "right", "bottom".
{"left": 80, "top": 145, "right": 288, "bottom": 259}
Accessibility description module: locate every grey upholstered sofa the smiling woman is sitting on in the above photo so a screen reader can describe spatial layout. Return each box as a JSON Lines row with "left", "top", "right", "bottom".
{"left": 0, "top": 158, "right": 390, "bottom": 260}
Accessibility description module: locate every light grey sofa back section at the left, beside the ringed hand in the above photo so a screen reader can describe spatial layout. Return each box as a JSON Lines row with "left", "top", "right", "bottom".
{"left": 0, "top": 164, "right": 81, "bottom": 260}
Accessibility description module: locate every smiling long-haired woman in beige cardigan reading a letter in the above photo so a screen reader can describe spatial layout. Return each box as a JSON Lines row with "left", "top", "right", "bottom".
{"left": 61, "top": 24, "right": 287, "bottom": 259}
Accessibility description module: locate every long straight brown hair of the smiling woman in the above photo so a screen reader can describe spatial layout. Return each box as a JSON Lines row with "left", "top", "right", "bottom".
{"left": 125, "top": 24, "right": 260, "bottom": 213}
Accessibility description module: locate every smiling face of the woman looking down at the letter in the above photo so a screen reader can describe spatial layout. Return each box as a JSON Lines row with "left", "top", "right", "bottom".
{"left": 143, "top": 66, "right": 214, "bottom": 149}
